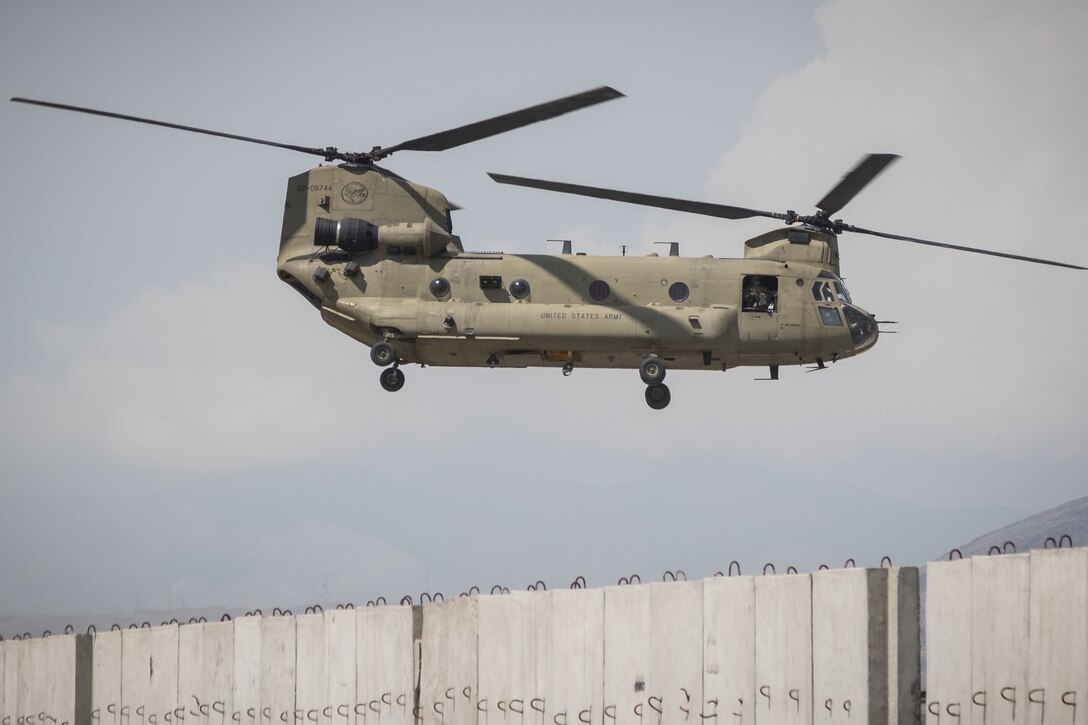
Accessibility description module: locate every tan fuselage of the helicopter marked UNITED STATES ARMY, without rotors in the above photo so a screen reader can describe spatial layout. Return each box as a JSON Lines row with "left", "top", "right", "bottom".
{"left": 279, "top": 167, "right": 877, "bottom": 370}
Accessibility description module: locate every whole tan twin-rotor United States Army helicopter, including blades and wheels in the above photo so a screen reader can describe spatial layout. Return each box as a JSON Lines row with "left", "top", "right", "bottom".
{"left": 11, "top": 87, "right": 1086, "bottom": 409}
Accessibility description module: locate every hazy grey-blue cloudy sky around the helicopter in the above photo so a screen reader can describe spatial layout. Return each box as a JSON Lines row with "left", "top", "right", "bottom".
{"left": 0, "top": 0, "right": 1088, "bottom": 614}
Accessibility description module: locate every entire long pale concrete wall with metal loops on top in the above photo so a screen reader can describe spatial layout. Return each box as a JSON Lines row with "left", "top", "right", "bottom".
{"left": 23, "top": 549, "right": 1088, "bottom": 725}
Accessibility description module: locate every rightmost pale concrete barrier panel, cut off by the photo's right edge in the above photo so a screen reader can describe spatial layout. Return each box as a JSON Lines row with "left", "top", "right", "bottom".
{"left": 1027, "top": 549, "right": 1088, "bottom": 725}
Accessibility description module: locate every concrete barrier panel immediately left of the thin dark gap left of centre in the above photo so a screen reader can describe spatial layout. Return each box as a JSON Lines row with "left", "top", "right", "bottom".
{"left": 351, "top": 606, "right": 413, "bottom": 725}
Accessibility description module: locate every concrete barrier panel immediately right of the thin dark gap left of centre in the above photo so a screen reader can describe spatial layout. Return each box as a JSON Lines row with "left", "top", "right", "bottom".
{"left": 417, "top": 597, "right": 478, "bottom": 725}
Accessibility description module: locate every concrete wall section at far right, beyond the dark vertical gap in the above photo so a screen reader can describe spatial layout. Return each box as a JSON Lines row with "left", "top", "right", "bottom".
{"left": 926, "top": 549, "right": 1088, "bottom": 725}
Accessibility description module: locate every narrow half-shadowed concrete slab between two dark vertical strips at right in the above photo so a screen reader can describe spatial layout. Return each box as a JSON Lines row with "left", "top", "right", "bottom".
{"left": 888, "top": 566, "right": 922, "bottom": 725}
